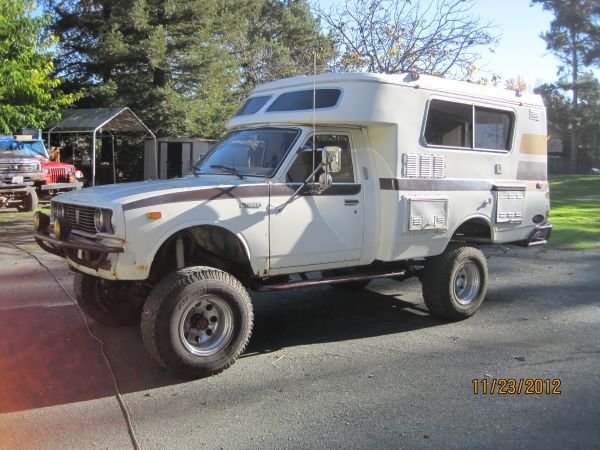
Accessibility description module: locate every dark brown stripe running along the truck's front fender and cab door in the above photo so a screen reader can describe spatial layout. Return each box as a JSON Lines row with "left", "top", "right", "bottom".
{"left": 123, "top": 184, "right": 362, "bottom": 211}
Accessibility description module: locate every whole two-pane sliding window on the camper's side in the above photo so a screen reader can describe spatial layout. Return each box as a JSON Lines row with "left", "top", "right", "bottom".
{"left": 425, "top": 100, "right": 514, "bottom": 151}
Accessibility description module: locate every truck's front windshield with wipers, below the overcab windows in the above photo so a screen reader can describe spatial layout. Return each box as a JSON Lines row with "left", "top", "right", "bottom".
{"left": 194, "top": 128, "right": 300, "bottom": 177}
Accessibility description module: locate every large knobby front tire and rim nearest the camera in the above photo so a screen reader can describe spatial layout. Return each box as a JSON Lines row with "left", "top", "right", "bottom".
{"left": 142, "top": 266, "right": 254, "bottom": 378}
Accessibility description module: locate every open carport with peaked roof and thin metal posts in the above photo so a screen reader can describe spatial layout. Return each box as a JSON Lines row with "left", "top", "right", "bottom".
{"left": 48, "top": 107, "right": 156, "bottom": 186}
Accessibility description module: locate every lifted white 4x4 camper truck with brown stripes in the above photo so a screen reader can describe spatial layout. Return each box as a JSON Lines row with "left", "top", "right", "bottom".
{"left": 35, "top": 74, "right": 551, "bottom": 377}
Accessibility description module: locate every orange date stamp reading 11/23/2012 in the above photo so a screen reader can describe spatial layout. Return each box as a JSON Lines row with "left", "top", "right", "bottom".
{"left": 471, "top": 378, "right": 561, "bottom": 395}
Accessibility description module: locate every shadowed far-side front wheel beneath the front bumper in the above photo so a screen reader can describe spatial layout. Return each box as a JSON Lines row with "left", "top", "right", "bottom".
{"left": 73, "top": 273, "right": 147, "bottom": 326}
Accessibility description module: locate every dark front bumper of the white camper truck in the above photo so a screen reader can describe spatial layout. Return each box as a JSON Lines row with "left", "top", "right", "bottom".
{"left": 33, "top": 230, "right": 125, "bottom": 270}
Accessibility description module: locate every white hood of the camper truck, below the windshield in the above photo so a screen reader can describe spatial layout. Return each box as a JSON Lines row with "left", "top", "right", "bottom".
{"left": 57, "top": 175, "right": 266, "bottom": 206}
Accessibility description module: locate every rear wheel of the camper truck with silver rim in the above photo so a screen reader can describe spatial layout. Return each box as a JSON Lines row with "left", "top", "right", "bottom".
{"left": 421, "top": 244, "right": 488, "bottom": 321}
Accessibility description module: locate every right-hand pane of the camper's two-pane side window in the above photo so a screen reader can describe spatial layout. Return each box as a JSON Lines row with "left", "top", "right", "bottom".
{"left": 475, "top": 107, "right": 512, "bottom": 150}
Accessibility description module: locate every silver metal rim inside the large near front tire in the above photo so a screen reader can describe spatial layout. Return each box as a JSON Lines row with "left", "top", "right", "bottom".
{"left": 179, "top": 295, "right": 233, "bottom": 356}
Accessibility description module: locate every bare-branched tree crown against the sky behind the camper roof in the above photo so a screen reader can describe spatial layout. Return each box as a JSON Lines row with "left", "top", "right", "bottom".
{"left": 316, "top": 0, "right": 498, "bottom": 78}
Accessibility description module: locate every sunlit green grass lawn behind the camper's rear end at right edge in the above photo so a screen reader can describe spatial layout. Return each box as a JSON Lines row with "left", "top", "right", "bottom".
{"left": 549, "top": 175, "right": 600, "bottom": 250}
